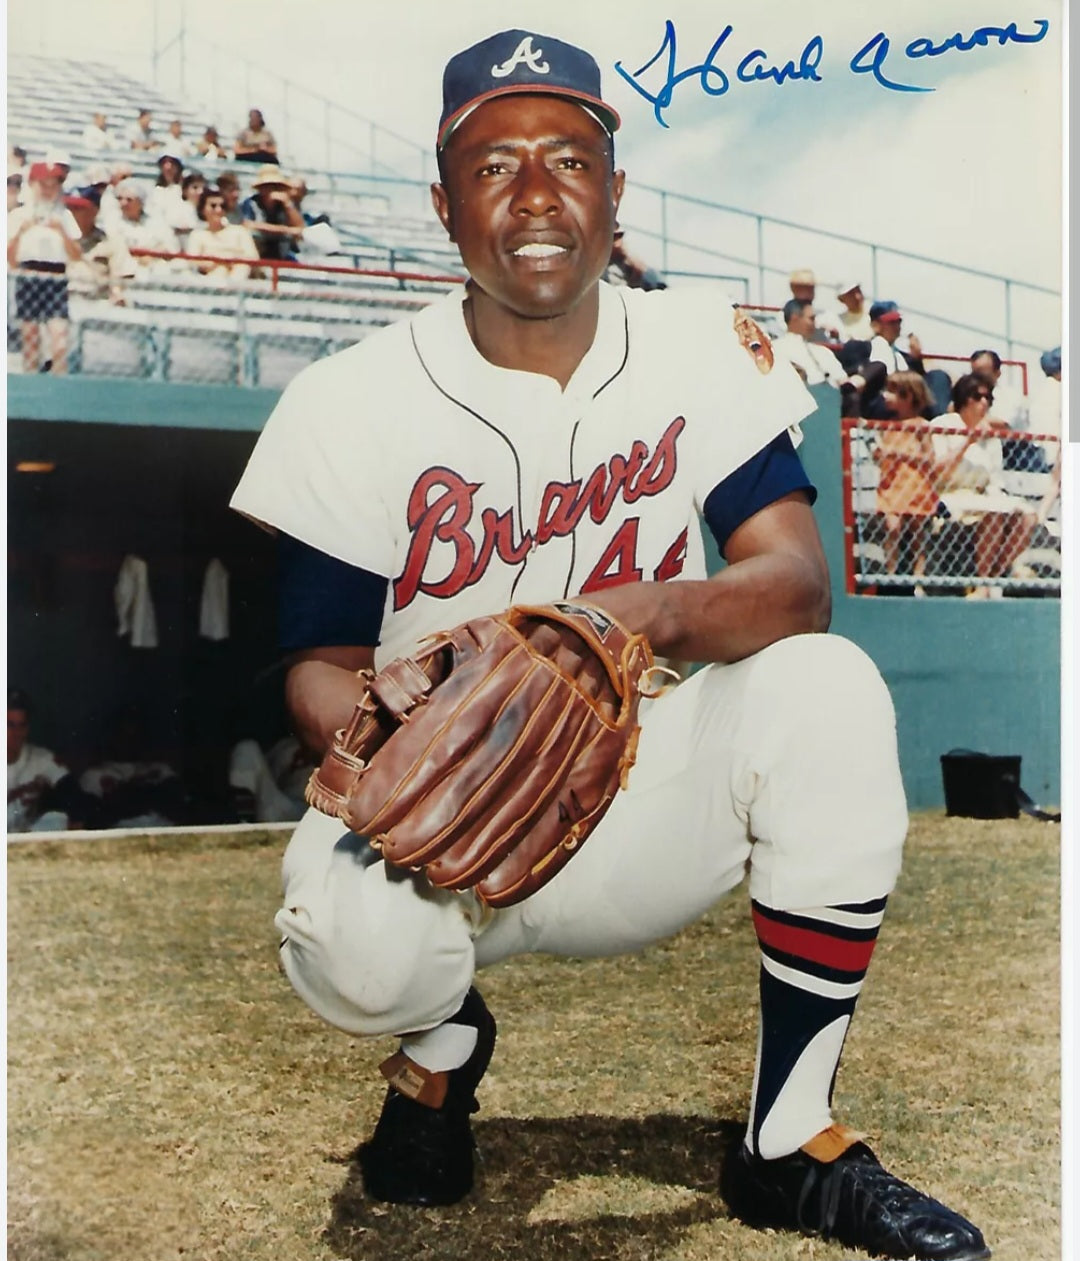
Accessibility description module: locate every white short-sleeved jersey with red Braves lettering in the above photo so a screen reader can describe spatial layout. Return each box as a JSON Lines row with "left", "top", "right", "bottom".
{"left": 232, "top": 284, "right": 814, "bottom": 667}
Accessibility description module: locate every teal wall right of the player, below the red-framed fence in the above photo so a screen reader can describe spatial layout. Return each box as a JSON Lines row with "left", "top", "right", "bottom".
{"left": 800, "top": 386, "right": 1061, "bottom": 810}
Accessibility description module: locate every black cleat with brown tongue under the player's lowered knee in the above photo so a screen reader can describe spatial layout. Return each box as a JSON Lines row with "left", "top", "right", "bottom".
{"left": 360, "top": 989, "right": 496, "bottom": 1206}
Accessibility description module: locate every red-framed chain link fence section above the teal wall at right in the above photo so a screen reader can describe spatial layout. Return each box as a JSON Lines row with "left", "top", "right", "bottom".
{"left": 843, "top": 415, "right": 1061, "bottom": 599}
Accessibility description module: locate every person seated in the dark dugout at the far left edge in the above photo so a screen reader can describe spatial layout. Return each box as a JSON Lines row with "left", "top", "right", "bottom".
{"left": 8, "top": 689, "right": 86, "bottom": 832}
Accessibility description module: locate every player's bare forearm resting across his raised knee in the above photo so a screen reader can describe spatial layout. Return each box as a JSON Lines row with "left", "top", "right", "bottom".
{"left": 584, "top": 552, "right": 831, "bottom": 662}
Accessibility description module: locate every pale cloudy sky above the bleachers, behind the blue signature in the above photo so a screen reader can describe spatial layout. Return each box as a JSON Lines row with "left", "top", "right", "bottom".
{"left": 9, "top": 0, "right": 1062, "bottom": 342}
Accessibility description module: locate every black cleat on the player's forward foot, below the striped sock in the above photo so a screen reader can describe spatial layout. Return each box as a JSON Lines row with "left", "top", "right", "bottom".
{"left": 720, "top": 1142, "right": 990, "bottom": 1261}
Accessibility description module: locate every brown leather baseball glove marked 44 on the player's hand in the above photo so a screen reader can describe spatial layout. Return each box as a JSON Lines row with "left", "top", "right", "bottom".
{"left": 307, "top": 603, "right": 652, "bottom": 907}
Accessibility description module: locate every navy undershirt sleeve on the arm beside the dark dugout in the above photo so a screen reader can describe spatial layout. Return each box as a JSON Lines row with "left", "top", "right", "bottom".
{"left": 278, "top": 532, "right": 390, "bottom": 652}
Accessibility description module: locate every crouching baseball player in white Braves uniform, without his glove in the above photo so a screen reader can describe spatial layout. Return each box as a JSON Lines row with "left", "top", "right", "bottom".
{"left": 232, "top": 30, "right": 989, "bottom": 1261}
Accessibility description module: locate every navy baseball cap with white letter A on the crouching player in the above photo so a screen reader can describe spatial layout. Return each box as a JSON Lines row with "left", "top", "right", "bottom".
{"left": 435, "top": 30, "right": 621, "bottom": 149}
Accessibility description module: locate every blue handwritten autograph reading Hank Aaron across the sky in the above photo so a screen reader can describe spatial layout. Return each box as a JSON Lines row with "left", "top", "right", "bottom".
{"left": 614, "top": 18, "right": 1050, "bottom": 127}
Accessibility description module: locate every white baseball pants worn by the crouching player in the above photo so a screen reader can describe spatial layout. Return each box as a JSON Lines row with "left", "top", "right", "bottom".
{"left": 275, "top": 634, "right": 907, "bottom": 1035}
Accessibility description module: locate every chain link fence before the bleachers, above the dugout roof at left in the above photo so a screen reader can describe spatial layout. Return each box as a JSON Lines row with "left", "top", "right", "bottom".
{"left": 8, "top": 251, "right": 453, "bottom": 390}
